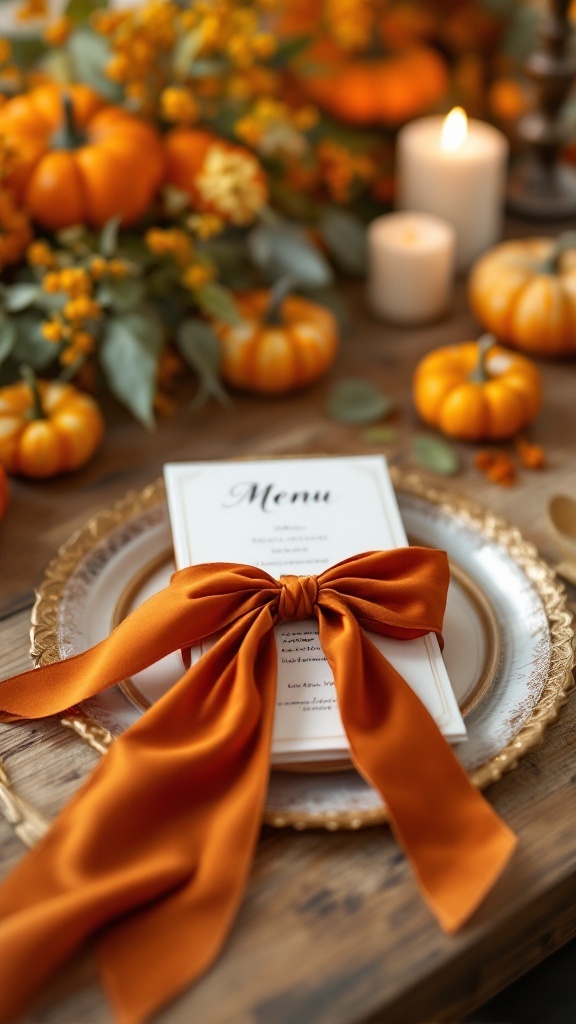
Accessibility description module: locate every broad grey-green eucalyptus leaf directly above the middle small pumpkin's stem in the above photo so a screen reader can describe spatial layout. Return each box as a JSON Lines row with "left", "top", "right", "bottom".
{"left": 248, "top": 223, "right": 332, "bottom": 288}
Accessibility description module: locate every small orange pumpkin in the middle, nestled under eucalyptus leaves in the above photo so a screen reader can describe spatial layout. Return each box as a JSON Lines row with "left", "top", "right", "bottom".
{"left": 215, "top": 292, "right": 338, "bottom": 394}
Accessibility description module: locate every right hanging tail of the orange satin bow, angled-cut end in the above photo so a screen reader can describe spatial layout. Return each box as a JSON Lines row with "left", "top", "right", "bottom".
{"left": 319, "top": 602, "right": 517, "bottom": 932}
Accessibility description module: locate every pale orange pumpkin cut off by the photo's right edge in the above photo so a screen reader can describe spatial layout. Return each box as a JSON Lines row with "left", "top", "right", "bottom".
{"left": 468, "top": 232, "right": 576, "bottom": 356}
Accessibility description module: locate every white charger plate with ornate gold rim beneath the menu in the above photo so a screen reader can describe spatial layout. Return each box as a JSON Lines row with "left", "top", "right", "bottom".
{"left": 3, "top": 471, "right": 574, "bottom": 829}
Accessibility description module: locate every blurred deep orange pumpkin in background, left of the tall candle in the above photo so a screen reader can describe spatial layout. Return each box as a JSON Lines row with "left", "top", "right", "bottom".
{"left": 302, "top": 46, "right": 449, "bottom": 127}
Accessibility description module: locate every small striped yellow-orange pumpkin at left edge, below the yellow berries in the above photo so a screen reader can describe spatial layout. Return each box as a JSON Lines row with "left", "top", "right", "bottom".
{"left": 0, "top": 375, "right": 104, "bottom": 479}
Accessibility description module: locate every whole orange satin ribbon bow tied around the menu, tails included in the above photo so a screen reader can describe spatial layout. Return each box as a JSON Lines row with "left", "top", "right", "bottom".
{"left": 0, "top": 548, "right": 516, "bottom": 1024}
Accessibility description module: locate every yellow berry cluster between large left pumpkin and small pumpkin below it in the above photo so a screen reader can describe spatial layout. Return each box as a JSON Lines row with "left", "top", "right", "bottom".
{"left": 28, "top": 247, "right": 128, "bottom": 366}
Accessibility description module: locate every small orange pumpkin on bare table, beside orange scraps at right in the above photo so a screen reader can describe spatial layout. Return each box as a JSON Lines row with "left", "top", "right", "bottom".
{"left": 413, "top": 335, "right": 541, "bottom": 441}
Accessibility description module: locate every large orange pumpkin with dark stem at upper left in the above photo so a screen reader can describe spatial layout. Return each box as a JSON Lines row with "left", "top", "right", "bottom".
{"left": 0, "top": 85, "right": 164, "bottom": 230}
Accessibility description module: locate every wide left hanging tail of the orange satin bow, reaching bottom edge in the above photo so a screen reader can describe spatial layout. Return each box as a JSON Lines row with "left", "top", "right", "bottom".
{"left": 0, "top": 607, "right": 276, "bottom": 1024}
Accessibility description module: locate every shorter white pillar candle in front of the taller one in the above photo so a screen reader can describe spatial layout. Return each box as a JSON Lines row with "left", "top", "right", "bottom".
{"left": 368, "top": 213, "right": 455, "bottom": 325}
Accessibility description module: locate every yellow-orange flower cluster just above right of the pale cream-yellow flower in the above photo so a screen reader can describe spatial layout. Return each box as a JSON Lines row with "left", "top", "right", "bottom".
{"left": 234, "top": 96, "right": 318, "bottom": 158}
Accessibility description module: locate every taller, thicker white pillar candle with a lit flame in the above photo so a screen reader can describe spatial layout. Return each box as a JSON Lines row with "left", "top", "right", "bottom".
{"left": 397, "top": 108, "right": 508, "bottom": 270}
